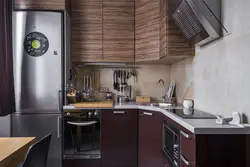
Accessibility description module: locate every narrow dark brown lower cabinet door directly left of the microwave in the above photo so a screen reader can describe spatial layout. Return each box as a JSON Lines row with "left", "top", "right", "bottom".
{"left": 138, "top": 111, "right": 163, "bottom": 167}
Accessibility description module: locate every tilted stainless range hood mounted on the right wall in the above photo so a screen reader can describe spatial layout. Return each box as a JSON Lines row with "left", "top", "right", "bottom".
{"left": 172, "top": 0, "right": 225, "bottom": 46}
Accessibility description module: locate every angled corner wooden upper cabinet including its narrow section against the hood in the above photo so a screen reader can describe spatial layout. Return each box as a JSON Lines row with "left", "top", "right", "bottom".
{"left": 135, "top": 0, "right": 195, "bottom": 64}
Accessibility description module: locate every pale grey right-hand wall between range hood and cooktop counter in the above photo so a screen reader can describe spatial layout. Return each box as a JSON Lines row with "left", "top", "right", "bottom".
{"left": 171, "top": 0, "right": 250, "bottom": 120}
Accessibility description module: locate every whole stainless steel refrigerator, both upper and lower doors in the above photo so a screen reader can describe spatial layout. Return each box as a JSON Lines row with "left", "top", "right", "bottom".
{"left": 11, "top": 11, "right": 71, "bottom": 167}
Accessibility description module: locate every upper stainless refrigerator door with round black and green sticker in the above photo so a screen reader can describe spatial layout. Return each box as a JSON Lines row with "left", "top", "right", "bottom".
{"left": 13, "top": 11, "right": 64, "bottom": 113}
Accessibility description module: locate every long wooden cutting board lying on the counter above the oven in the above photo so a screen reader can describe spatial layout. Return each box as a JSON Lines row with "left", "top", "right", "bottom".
{"left": 74, "top": 100, "right": 113, "bottom": 108}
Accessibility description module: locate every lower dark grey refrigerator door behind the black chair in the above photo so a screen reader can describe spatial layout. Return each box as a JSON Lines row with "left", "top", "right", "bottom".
{"left": 12, "top": 114, "right": 62, "bottom": 167}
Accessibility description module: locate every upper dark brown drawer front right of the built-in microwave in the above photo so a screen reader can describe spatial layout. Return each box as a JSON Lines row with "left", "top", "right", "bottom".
{"left": 180, "top": 130, "right": 196, "bottom": 163}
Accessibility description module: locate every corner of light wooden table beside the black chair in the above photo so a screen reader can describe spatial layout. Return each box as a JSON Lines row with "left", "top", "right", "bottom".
{"left": 0, "top": 137, "right": 35, "bottom": 167}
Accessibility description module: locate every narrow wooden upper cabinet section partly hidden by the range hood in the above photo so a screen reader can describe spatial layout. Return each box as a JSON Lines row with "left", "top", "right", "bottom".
{"left": 160, "top": 0, "right": 195, "bottom": 63}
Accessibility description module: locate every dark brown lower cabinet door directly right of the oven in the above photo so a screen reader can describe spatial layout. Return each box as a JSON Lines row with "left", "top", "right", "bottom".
{"left": 101, "top": 110, "right": 137, "bottom": 167}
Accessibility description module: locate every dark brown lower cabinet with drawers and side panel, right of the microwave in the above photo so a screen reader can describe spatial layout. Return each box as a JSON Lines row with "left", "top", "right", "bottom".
{"left": 180, "top": 123, "right": 247, "bottom": 167}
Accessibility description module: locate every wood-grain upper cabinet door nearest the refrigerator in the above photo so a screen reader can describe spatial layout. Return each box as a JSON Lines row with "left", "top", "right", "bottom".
{"left": 71, "top": 0, "right": 102, "bottom": 62}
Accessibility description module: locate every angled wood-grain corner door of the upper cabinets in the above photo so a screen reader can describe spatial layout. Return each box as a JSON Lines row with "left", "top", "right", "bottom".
{"left": 135, "top": 0, "right": 160, "bottom": 62}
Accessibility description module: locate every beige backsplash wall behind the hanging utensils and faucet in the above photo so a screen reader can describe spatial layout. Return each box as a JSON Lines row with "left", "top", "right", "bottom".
{"left": 77, "top": 65, "right": 170, "bottom": 100}
